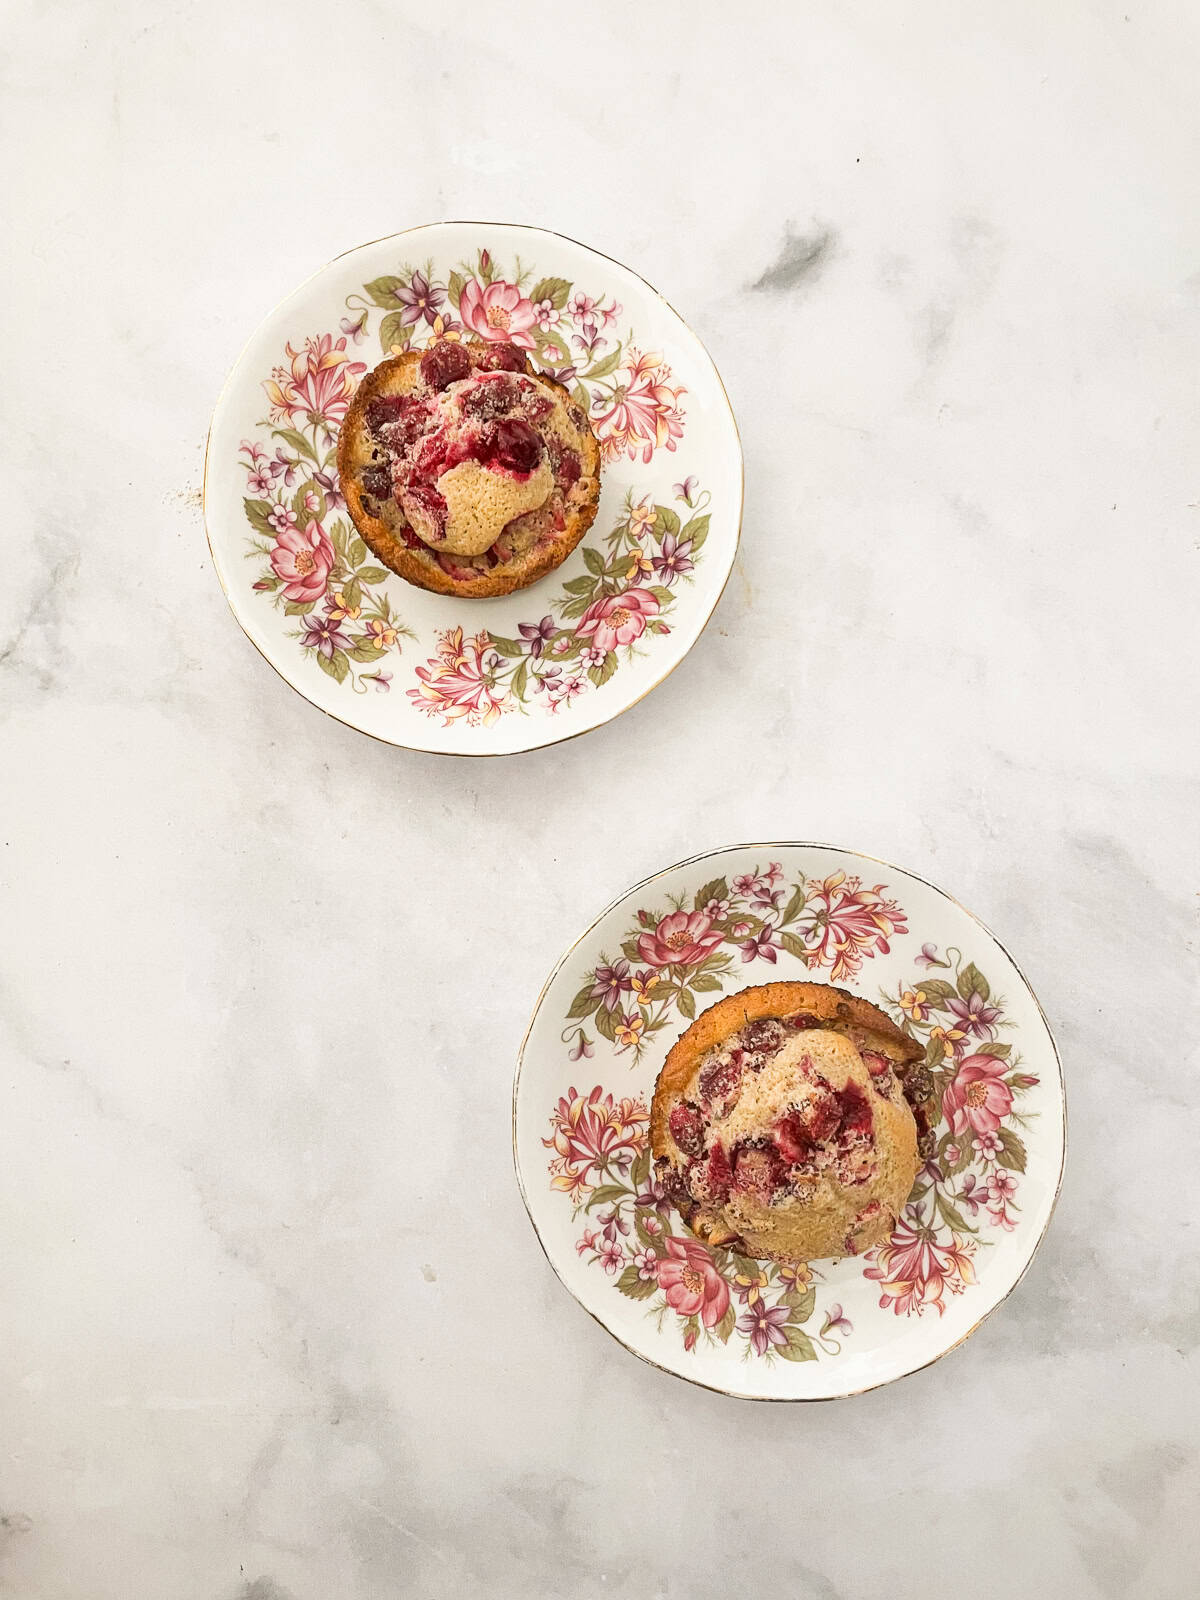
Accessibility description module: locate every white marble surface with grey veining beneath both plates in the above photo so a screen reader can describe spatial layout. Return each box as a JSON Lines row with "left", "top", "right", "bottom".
{"left": 0, "top": 0, "right": 1200, "bottom": 1600}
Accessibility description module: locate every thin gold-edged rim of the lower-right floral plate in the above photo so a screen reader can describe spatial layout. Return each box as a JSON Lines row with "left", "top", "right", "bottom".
{"left": 512, "top": 838, "right": 1067, "bottom": 1405}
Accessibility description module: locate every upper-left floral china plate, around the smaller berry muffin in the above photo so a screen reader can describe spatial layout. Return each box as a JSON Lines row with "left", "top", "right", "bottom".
{"left": 205, "top": 222, "right": 742, "bottom": 755}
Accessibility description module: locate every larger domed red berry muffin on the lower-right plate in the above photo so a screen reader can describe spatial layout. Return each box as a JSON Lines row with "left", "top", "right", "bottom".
{"left": 650, "top": 982, "right": 928, "bottom": 1261}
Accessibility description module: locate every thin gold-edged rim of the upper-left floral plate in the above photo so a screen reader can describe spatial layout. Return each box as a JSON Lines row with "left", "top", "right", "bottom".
{"left": 200, "top": 218, "right": 746, "bottom": 762}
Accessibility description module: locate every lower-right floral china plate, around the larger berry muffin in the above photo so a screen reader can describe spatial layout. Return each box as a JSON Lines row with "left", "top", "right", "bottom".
{"left": 512, "top": 843, "right": 1066, "bottom": 1400}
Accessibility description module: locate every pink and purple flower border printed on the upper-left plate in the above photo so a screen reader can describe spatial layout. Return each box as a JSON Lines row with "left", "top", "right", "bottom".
{"left": 238, "top": 250, "right": 710, "bottom": 707}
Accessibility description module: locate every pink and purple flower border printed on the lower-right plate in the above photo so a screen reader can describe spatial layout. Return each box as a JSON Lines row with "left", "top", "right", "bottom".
{"left": 542, "top": 862, "right": 1040, "bottom": 1362}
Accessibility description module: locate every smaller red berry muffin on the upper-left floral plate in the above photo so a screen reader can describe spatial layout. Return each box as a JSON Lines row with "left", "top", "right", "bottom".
{"left": 338, "top": 339, "right": 600, "bottom": 598}
